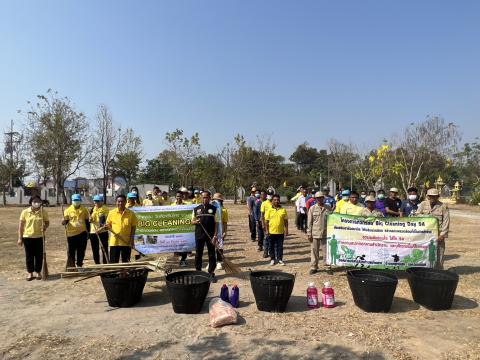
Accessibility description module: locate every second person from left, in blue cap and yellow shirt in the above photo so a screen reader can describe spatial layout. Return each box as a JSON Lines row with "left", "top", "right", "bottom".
{"left": 62, "top": 194, "right": 90, "bottom": 268}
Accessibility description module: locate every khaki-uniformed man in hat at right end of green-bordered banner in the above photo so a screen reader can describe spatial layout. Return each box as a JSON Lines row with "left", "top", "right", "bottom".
{"left": 415, "top": 189, "right": 450, "bottom": 269}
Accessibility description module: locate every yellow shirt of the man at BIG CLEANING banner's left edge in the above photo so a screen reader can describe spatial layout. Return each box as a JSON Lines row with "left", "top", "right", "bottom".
{"left": 107, "top": 208, "right": 138, "bottom": 246}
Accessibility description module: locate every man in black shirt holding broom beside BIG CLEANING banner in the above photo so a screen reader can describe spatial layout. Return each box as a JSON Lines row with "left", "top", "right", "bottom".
{"left": 192, "top": 191, "right": 219, "bottom": 282}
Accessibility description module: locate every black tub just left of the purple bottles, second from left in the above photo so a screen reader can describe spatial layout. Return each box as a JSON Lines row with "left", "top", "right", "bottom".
{"left": 166, "top": 271, "right": 210, "bottom": 314}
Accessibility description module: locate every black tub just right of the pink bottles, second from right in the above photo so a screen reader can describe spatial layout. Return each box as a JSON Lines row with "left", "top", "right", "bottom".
{"left": 347, "top": 270, "right": 398, "bottom": 312}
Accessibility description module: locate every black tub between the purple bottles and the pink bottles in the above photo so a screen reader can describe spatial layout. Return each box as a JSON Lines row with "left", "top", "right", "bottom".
{"left": 250, "top": 271, "right": 295, "bottom": 312}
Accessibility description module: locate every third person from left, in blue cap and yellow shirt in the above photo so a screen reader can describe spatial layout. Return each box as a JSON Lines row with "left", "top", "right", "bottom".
{"left": 89, "top": 195, "right": 109, "bottom": 264}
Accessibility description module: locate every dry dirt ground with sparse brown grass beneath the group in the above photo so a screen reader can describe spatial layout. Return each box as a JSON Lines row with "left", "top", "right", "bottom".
{"left": 0, "top": 204, "right": 480, "bottom": 360}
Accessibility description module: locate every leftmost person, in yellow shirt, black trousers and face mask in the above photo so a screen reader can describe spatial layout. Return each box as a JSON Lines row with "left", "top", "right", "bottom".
{"left": 17, "top": 196, "right": 50, "bottom": 281}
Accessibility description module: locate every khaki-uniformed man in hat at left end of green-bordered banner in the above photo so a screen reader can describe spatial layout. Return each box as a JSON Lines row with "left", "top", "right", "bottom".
{"left": 307, "top": 191, "right": 331, "bottom": 275}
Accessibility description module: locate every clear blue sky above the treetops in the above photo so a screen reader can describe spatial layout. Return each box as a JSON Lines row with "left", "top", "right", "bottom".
{"left": 0, "top": 0, "right": 480, "bottom": 158}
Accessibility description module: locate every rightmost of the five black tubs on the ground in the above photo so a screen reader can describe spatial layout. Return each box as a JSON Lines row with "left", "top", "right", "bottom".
{"left": 407, "top": 268, "right": 458, "bottom": 310}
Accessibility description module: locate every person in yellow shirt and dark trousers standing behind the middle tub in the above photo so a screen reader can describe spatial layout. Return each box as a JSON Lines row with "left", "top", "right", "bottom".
{"left": 265, "top": 194, "right": 288, "bottom": 266}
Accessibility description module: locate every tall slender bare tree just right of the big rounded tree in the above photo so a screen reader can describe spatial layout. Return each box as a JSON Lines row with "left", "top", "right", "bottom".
{"left": 92, "top": 104, "right": 121, "bottom": 199}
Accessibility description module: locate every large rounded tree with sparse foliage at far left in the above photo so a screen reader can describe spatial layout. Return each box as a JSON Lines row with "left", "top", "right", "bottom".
{"left": 26, "top": 89, "right": 91, "bottom": 204}
